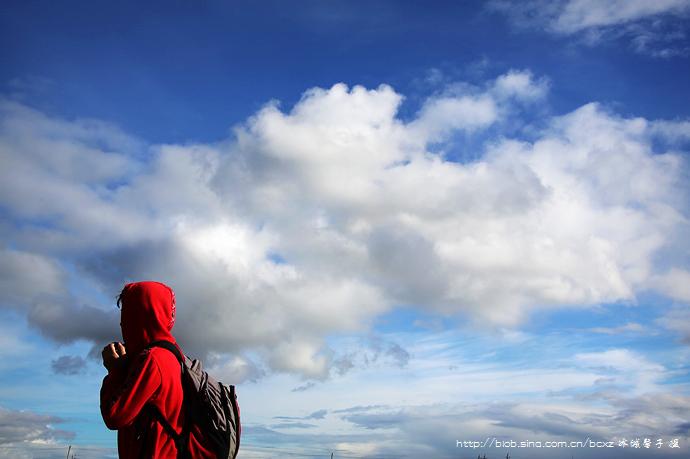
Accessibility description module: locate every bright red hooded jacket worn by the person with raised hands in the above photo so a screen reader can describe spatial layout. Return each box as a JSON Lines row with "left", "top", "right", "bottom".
{"left": 101, "top": 282, "right": 214, "bottom": 459}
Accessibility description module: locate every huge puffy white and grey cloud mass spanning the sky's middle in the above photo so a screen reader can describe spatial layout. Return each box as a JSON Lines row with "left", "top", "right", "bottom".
{"left": 0, "top": 71, "right": 688, "bottom": 379}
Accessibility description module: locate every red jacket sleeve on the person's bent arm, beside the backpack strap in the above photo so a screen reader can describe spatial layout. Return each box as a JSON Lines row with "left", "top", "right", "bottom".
{"left": 101, "top": 353, "right": 161, "bottom": 430}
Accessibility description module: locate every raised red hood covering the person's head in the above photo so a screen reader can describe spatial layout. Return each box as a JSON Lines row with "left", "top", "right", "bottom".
{"left": 118, "top": 281, "right": 175, "bottom": 355}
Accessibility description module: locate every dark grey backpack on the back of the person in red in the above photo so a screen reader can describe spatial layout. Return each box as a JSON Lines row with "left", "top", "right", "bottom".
{"left": 148, "top": 341, "right": 241, "bottom": 459}
